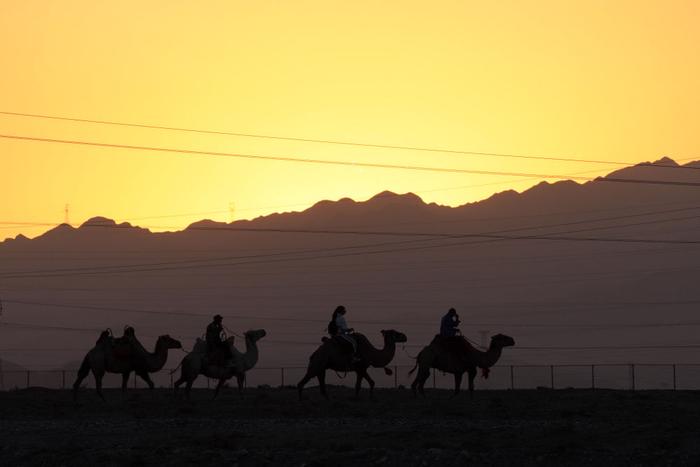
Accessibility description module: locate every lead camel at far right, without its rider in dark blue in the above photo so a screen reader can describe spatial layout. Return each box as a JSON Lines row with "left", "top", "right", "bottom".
{"left": 408, "top": 334, "right": 515, "bottom": 397}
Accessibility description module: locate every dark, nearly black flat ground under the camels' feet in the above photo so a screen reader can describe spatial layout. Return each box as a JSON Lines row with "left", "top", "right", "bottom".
{"left": 0, "top": 388, "right": 700, "bottom": 467}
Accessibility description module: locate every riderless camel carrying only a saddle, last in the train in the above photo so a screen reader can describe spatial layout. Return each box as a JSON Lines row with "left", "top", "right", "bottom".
{"left": 73, "top": 334, "right": 182, "bottom": 400}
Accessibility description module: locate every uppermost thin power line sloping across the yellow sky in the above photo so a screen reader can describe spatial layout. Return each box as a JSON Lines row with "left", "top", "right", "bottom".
{"left": 5, "top": 111, "right": 698, "bottom": 169}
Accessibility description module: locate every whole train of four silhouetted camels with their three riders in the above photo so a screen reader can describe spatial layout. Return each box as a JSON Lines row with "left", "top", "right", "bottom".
{"left": 73, "top": 306, "right": 515, "bottom": 400}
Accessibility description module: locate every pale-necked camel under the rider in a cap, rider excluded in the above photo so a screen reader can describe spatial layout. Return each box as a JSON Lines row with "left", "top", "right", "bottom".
{"left": 175, "top": 329, "right": 267, "bottom": 399}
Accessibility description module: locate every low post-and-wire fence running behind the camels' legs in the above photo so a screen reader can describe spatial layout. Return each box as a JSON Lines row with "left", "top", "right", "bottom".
{"left": 0, "top": 364, "right": 700, "bottom": 390}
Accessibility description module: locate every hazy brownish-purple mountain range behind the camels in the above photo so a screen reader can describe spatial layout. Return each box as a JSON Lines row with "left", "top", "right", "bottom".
{"left": 0, "top": 158, "right": 700, "bottom": 374}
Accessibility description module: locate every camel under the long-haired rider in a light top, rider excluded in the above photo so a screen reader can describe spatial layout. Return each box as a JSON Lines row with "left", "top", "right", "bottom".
{"left": 297, "top": 330, "right": 408, "bottom": 400}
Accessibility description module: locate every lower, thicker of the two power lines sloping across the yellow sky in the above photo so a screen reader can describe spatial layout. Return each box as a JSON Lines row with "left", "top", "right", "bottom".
{"left": 0, "top": 134, "right": 700, "bottom": 187}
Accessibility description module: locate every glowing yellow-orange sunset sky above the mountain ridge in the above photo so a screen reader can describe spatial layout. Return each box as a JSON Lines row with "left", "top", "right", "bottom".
{"left": 0, "top": 0, "right": 700, "bottom": 238}
